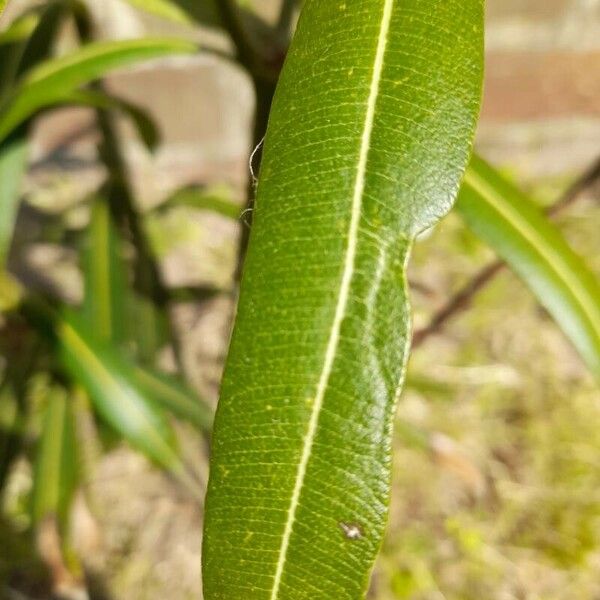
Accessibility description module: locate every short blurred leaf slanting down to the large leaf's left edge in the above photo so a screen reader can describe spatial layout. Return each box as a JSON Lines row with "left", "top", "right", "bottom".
{"left": 134, "top": 367, "right": 213, "bottom": 433}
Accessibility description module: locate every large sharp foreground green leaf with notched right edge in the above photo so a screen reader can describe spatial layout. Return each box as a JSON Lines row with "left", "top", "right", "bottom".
{"left": 203, "top": 0, "right": 483, "bottom": 600}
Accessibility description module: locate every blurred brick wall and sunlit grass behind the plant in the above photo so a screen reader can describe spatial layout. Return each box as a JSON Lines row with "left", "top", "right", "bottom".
{"left": 0, "top": 0, "right": 600, "bottom": 600}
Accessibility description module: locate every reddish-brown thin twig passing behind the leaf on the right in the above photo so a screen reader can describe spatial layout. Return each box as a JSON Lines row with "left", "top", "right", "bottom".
{"left": 412, "top": 157, "right": 600, "bottom": 349}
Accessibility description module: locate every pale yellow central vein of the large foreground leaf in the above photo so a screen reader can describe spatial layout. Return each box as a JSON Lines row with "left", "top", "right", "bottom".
{"left": 271, "top": 0, "right": 394, "bottom": 600}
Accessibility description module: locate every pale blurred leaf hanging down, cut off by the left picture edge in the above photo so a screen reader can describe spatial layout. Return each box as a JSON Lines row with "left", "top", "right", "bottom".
{"left": 0, "top": 136, "right": 28, "bottom": 270}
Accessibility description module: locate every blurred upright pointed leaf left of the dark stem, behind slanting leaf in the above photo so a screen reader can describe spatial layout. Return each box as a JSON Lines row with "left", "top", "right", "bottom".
{"left": 83, "top": 196, "right": 127, "bottom": 342}
